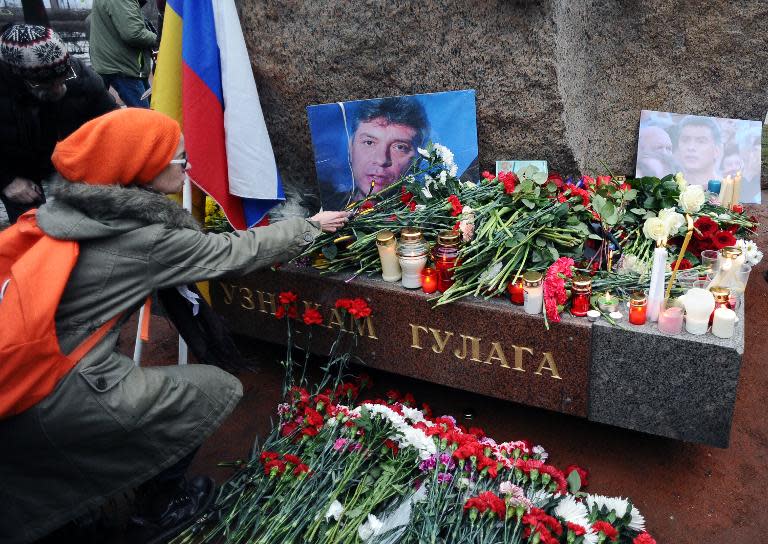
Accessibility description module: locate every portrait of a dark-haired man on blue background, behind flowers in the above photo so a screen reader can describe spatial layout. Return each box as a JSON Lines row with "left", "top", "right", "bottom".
{"left": 307, "top": 90, "right": 480, "bottom": 210}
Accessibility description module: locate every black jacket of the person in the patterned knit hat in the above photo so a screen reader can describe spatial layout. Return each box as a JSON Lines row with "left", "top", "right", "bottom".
{"left": 0, "top": 59, "right": 118, "bottom": 190}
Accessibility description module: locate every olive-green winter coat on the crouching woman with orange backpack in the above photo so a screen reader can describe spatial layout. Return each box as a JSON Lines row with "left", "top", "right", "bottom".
{"left": 0, "top": 177, "right": 320, "bottom": 544}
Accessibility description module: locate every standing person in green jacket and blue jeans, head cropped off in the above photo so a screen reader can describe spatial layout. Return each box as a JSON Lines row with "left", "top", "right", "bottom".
{"left": 90, "top": 0, "right": 157, "bottom": 108}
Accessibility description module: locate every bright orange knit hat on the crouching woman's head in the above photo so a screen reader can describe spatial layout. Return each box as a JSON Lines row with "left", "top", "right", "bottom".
{"left": 51, "top": 108, "right": 181, "bottom": 185}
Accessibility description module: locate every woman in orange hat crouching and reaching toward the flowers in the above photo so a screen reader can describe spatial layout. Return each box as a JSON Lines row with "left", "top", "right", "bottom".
{"left": 0, "top": 108, "right": 347, "bottom": 543}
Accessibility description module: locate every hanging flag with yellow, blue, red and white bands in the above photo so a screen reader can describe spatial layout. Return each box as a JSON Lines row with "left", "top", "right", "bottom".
{"left": 152, "top": 0, "right": 285, "bottom": 229}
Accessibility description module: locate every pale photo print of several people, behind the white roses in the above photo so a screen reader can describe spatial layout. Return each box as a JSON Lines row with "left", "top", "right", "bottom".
{"left": 635, "top": 110, "right": 763, "bottom": 204}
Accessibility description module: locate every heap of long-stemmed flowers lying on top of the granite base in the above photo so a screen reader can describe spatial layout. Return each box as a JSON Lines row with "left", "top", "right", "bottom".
{"left": 302, "top": 144, "right": 762, "bottom": 321}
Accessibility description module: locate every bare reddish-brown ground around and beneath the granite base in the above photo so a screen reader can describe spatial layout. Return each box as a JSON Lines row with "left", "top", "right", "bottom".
{"left": 57, "top": 198, "right": 768, "bottom": 544}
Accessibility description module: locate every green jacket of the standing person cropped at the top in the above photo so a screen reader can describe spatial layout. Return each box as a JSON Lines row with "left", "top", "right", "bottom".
{"left": 90, "top": 0, "right": 157, "bottom": 78}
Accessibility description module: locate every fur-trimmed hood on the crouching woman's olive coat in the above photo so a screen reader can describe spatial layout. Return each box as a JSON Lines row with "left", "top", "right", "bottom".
{"left": 37, "top": 177, "right": 200, "bottom": 240}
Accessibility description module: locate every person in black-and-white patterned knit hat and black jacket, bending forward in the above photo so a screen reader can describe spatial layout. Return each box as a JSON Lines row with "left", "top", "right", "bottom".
{"left": 0, "top": 24, "right": 117, "bottom": 223}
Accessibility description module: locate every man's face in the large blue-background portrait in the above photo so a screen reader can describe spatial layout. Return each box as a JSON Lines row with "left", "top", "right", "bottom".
{"left": 349, "top": 117, "right": 417, "bottom": 195}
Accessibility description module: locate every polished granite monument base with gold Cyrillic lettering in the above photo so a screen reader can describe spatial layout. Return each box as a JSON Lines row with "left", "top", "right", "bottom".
{"left": 211, "top": 266, "right": 744, "bottom": 447}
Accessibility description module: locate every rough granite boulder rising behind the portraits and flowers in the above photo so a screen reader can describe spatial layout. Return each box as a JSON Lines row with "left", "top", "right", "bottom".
{"left": 240, "top": 0, "right": 768, "bottom": 208}
